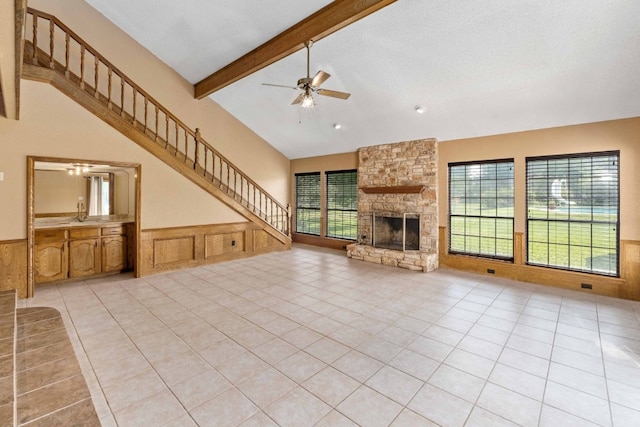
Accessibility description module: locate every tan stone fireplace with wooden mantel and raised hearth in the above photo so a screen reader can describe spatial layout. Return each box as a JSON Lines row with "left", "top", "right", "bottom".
{"left": 347, "top": 139, "right": 438, "bottom": 272}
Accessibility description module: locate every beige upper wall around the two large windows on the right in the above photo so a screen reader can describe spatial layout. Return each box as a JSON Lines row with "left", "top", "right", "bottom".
{"left": 438, "top": 117, "right": 640, "bottom": 240}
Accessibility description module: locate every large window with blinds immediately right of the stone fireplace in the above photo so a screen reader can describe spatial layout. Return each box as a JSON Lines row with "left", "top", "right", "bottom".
{"left": 449, "top": 159, "right": 513, "bottom": 260}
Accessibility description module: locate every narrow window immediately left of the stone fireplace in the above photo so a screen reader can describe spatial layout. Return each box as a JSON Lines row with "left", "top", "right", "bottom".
{"left": 326, "top": 170, "right": 358, "bottom": 240}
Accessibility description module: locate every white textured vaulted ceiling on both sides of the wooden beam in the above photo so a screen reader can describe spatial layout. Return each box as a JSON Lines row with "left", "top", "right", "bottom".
{"left": 87, "top": 0, "right": 640, "bottom": 159}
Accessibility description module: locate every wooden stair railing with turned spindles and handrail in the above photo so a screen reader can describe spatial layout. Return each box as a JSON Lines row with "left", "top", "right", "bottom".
{"left": 24, "top": 8, "right": 291, "bottom": 236}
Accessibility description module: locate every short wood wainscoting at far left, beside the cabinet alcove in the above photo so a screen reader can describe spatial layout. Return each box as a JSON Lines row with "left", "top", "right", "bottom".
{"left": 0, "top": 239, "right": 27, "bottom": 298}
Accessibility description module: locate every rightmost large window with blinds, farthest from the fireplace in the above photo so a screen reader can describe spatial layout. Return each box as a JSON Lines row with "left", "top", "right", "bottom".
{"left": 527, "top": 152, "right": 620, "bottom": 276}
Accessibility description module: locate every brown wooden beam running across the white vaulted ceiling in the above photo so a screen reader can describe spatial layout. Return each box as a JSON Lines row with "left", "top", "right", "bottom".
{"left": 194, "top": 0, "right": 396, "bottom": 99}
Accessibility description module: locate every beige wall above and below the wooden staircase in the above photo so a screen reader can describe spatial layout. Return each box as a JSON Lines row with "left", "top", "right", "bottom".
{"left": 0, "top": 0, "right": 290, "bottom": 240}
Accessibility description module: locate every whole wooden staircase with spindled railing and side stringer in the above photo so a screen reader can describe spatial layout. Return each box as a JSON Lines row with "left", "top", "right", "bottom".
{"left": 22, "top": 8, "right": 291, "bottom": 246}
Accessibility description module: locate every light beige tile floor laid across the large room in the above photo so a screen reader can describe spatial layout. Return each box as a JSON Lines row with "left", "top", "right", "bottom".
{"left": 20, "top": 245, "right": 640, "bottom": 426}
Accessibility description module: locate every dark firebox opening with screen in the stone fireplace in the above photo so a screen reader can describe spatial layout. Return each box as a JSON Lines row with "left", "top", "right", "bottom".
{"left": 373, "top": 214, "right": 420, "bottom": 251}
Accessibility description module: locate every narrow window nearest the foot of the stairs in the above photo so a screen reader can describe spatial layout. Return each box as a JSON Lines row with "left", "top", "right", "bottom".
{"left": 296, "top": 172, "right": 320, "bottom": 236}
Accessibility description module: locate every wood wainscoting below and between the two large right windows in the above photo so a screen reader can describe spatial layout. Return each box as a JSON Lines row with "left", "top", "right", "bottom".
{"left": 439, "top": 226, "right": 640, "bottom": 301}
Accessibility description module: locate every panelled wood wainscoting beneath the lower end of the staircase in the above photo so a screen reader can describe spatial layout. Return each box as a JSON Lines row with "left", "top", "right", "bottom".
{"left": 139, "top": 222, "right": 291, "bottom": 276}
